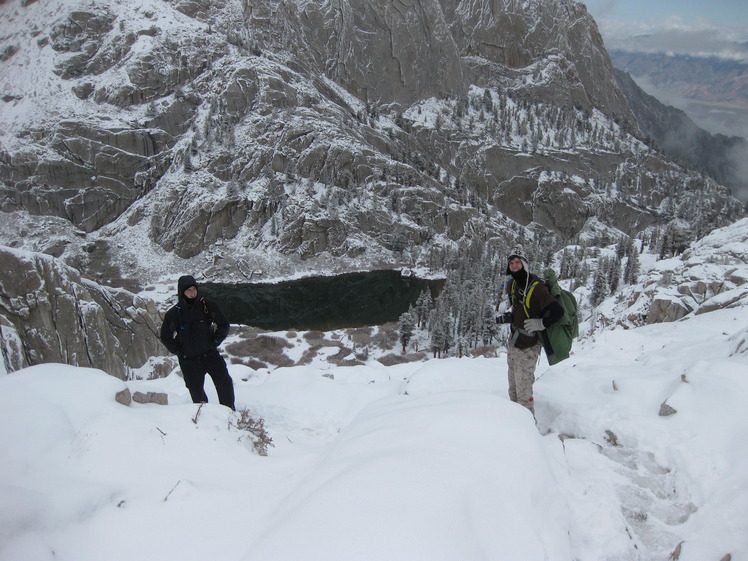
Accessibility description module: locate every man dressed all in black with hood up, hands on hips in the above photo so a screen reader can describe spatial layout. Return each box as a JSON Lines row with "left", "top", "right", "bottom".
{"left": 161, "top": 275, "right": 235, "bottom": 410}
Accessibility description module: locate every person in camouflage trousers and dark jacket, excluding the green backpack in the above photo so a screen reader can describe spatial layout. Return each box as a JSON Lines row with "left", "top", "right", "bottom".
{"left": 496, "top": 247, "right": 568, "bottom": 417}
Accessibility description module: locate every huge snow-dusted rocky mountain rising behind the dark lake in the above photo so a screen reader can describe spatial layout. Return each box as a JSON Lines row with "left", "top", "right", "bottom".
{"left": 0, "top": 0, "right": 743, "bottom": 280}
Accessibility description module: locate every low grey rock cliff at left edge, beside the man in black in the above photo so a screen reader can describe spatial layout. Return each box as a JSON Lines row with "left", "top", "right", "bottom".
{"left": 0, "top": 248, "right": 164, "bottom": 379}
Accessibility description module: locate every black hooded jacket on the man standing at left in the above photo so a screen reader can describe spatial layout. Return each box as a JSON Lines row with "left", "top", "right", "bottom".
{"left": 161, "top": 275, "right": 229, "bottom": 359}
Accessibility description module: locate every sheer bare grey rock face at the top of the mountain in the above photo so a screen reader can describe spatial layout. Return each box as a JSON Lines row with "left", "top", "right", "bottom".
{"left": 253, "top": 0, "right": 632, "bottom": 121}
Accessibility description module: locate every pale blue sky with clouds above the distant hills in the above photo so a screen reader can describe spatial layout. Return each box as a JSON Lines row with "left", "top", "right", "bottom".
{"left": 583, "top": 0, "right": 748, "bottom": 62}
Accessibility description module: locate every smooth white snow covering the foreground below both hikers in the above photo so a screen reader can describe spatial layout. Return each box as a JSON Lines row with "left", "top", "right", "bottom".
{"left": 0, "top": 298, "right": 748, "bottom": 561}
